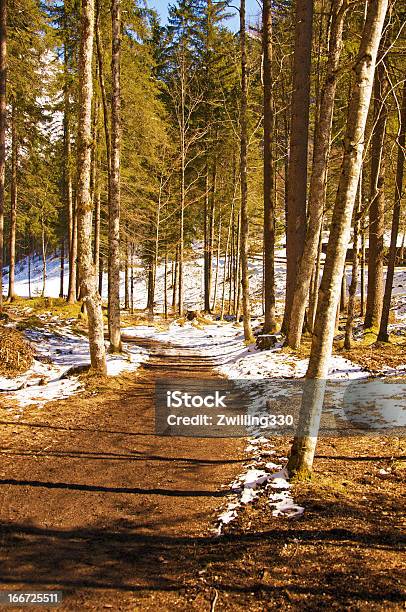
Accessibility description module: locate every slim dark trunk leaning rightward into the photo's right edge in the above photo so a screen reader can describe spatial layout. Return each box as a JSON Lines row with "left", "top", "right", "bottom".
{"left": 378, "top": 81, "right": 406, "bottom": 342}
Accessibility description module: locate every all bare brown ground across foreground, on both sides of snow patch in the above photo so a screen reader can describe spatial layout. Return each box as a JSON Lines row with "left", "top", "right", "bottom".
{"left": 0, "top": 346, "right": 405, "bottom": 612}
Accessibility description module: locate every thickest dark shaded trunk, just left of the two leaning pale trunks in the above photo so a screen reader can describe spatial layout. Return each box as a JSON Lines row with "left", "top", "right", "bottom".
{"left": 282, "top": 0, "right": 315, "bottom": 334}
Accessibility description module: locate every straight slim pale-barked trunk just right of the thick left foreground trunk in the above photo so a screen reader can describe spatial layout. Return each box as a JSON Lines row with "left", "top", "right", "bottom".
{"left": 109, "top": 0, "right": 122, "bottom": 353}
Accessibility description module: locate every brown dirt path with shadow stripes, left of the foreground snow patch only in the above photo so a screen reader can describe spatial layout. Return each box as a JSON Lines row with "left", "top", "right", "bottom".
{"left": 0, "top": 342, "right": 244, "bottom": 610}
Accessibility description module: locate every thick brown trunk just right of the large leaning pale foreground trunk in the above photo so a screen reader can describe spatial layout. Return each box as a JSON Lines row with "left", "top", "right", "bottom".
{"left": 364, "top": 59, "right": 389, "bottom": 329}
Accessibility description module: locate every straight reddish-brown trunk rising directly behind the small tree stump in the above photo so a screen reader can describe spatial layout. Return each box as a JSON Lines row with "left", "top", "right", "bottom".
{"left": 262, "top": 0, "right": 276, "bottom": 334}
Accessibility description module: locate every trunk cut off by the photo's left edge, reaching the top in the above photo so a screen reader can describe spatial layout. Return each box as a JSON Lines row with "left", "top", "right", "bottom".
{"left": 0, "top": 0, "right": 7, "bottom": 312}
